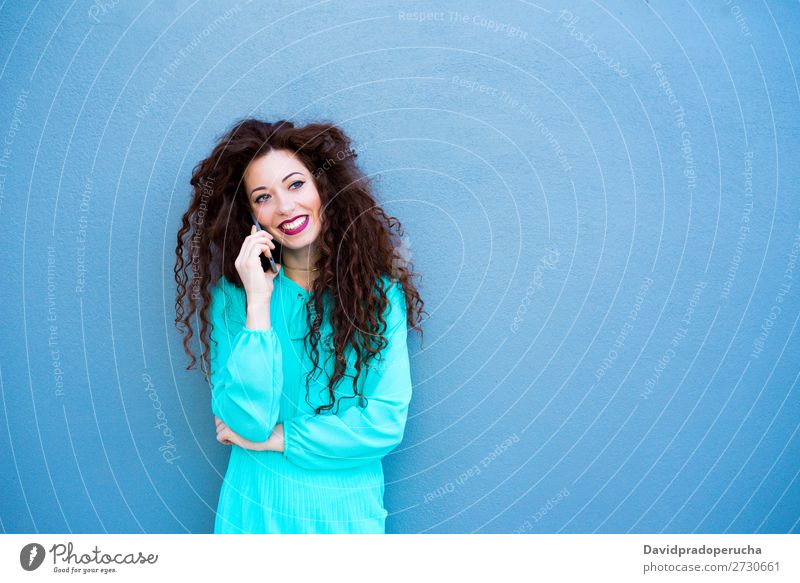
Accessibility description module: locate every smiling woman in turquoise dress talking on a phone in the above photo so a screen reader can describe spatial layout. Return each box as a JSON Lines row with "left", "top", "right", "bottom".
{"left": 175, "top": 119, "right": 424, "bottom": 533}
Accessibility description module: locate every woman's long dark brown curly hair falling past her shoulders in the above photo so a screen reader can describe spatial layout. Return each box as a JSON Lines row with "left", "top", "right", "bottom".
{"left": 175, "top": 119, "right": 425, "bottom": 414}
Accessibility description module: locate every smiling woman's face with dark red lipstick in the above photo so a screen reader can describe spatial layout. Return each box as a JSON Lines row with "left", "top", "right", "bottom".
{"left": 244, "top": 150, "right": 322, "bottom": 250}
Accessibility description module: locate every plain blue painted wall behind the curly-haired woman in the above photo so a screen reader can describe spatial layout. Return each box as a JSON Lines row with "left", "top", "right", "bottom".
{"left": 0, "top": 0, "right": 800, "bottom": 533}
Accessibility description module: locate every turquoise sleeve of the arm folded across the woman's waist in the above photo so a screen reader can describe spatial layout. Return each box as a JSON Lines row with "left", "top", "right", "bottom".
{"left": 283, "top": 283, "right": 412, "bottom": 470}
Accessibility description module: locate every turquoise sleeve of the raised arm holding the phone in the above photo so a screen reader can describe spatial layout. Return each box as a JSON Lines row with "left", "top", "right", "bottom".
{"left": 209, "top": 278, "right": 283, "bottom": 442}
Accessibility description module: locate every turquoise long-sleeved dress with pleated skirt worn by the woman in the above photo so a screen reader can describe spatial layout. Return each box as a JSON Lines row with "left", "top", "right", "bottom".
{"left": 209, "top": 269, "right": 412, "bottom": 533}
